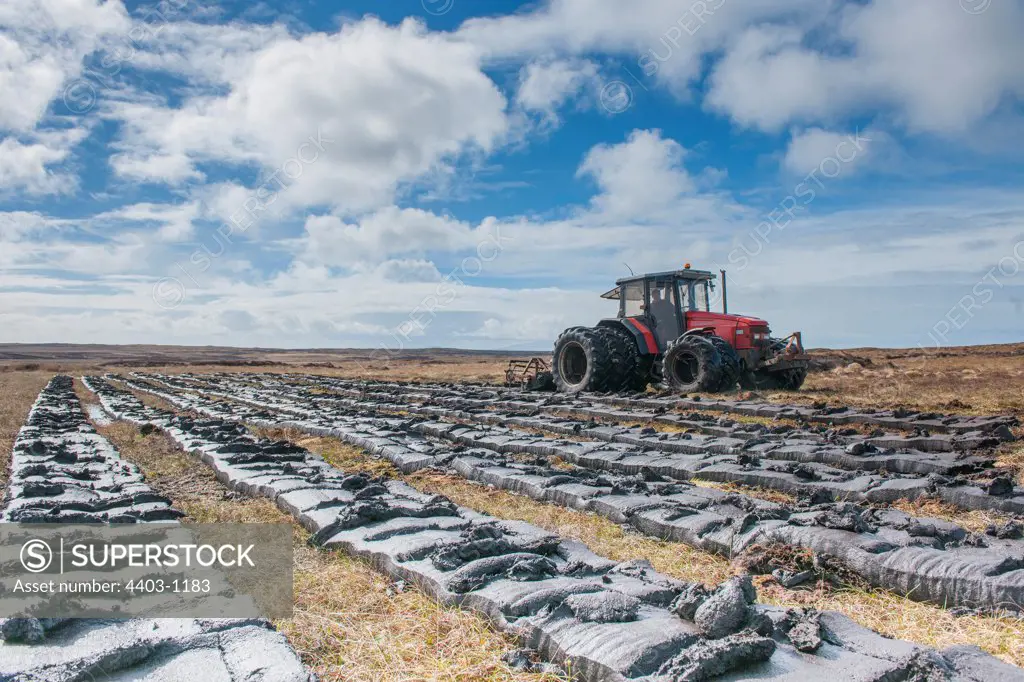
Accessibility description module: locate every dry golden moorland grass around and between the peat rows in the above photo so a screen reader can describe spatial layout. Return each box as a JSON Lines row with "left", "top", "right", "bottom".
{"left": 0, "top": 344, "right": 1024, "bottom": 682}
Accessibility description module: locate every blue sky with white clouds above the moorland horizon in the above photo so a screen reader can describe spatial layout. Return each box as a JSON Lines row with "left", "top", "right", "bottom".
{"left": 0, "top": 0, "right": 1024, "bottom": 349}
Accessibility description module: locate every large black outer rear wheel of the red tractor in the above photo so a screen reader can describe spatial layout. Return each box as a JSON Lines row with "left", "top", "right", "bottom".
{"left": 551, "top": 327, "right": 622, "bottom": 393}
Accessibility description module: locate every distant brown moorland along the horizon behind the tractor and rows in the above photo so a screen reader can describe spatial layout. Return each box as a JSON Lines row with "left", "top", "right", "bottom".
{"left": 0, "top": 343, "right": 1024, "bottom": 417}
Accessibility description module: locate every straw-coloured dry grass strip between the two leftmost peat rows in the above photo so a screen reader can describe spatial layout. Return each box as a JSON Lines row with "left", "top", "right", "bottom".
{"left": 90, "top": 413, "right": 563, "bottom": 682}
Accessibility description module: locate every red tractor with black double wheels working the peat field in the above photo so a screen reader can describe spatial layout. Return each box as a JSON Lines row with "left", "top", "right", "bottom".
{"left": 551, "top": 263, "right": 808, "bottom": 393}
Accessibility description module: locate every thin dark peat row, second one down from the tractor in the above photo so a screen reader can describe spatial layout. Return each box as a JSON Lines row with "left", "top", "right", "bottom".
{"left": 274, "top": 375, "right": 1002, "bottom": 453}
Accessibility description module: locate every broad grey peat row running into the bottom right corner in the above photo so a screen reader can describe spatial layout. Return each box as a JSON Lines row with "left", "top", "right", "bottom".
{"left": 81, "top": 380, "right": 1024, "bottom": 682}
